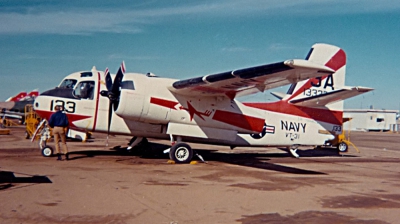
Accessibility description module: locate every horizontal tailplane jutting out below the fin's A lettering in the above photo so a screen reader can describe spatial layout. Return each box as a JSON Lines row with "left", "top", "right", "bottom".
{"left": 289, "top": 86, "right": 374, "bottom": 107}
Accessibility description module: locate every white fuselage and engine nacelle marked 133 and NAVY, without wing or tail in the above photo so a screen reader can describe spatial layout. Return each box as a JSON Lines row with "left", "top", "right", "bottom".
{"left": 34, "top": 71, "right": 341, "bottom": 149}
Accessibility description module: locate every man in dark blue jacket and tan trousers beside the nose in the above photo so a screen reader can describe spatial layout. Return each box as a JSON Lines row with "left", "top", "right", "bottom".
{"left": 49, "top": 105, "right": 69, "bottom": 161}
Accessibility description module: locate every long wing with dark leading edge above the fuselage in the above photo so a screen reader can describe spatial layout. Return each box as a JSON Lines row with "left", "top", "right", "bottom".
{"left": 169, "top": 59, "right": 335, "bottom": 99}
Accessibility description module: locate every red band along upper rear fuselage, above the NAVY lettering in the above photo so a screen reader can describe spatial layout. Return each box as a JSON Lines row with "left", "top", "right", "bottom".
{"left": 243, "top": 101, "right": 343, "bottom": 125}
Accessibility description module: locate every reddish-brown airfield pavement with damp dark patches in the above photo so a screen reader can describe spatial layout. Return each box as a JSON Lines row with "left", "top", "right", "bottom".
{"left": 0, "top": 128, "right": 400, "bottom": 224}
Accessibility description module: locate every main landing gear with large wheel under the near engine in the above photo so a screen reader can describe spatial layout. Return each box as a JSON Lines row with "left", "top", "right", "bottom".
{"left": 164, "top": 135, "right": 205, "bottom": 163}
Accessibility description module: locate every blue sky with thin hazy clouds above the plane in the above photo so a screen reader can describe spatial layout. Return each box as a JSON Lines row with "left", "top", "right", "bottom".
{"left": 0, "top": 0, "right": 400, "bottom": 110}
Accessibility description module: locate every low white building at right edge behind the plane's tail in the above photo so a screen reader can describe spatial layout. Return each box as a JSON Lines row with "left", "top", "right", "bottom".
{"left": 343, "top": 109, "right": 399, "bottom": 131}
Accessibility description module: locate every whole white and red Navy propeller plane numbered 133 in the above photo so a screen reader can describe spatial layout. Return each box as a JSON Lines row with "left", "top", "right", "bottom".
{"left": 34, "top": 44, "right": 372, "bottom": 163}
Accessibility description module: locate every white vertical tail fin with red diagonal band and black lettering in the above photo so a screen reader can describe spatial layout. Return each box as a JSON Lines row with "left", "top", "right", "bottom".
{"left": 283, "top": 44, "right": 346, "bottom": 111}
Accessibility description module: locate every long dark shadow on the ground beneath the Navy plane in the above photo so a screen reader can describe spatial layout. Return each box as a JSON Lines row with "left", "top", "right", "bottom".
{"left": 64, "top": 143, "right": 340, "bottom": 175}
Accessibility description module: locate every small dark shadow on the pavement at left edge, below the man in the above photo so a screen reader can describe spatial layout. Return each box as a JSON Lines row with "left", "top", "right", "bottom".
{"left": 0, "top": 171, "right": 52, "bottom": 190}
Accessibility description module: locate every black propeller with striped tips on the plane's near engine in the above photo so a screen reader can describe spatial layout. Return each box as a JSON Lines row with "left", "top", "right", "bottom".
{"left": 100, "top": 62, "right": 125, "bottom": 146}
